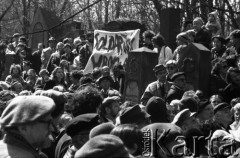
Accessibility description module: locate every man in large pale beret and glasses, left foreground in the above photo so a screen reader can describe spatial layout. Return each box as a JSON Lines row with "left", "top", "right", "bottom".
{"left": 0, "top": 96, "right": 55, "bottom": 158}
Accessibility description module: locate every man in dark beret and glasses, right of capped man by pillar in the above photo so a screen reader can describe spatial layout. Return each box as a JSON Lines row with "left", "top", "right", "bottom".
{"left": 167, "top": 72, "right": 186, "bottom": 104}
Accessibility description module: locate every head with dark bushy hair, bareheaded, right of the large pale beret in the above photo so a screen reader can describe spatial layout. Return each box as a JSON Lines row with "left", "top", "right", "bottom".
{"left": 72, "top": 85, "right": 103, "bottom": 116}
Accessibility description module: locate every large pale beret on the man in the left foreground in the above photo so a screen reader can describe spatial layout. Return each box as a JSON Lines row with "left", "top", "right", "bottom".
{"left": 0, "top": 96, "right": 55, "bottom": 127}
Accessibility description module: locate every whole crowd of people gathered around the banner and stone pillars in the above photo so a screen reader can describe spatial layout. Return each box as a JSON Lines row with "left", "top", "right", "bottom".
{"left": 0, "top": 12, "right": 240, "bottom": 158}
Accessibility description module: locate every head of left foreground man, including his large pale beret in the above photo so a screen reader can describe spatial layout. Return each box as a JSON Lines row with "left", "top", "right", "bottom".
{"left": 0, "top": 96, "right": 55, "bottom": 149}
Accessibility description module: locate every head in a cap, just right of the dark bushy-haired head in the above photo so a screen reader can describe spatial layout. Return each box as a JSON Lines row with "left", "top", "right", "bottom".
{"left": 99, "top": 96, "right": 120, "bottom": 122}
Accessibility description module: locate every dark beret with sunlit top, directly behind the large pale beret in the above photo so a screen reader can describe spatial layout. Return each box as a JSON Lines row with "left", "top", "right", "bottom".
{"left": 41, "top": 89, "right": 67, "bottom": 117}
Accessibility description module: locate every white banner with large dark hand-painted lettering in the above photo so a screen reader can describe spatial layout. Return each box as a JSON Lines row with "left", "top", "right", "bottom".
{"left": 84, "top": 29, "right": 140, "bottom": 74}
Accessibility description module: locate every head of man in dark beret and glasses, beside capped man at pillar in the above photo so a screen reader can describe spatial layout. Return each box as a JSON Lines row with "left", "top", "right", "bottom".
{"left": 171, "top": 72, "right": 186, "bottom": 89}
